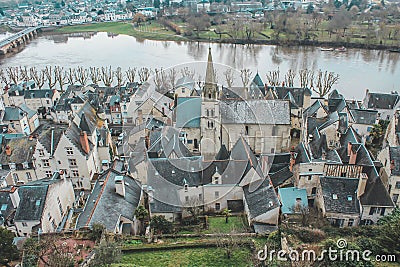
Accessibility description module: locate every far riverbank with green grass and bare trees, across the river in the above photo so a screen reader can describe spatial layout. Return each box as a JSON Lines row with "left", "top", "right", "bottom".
{"left": 46, "top": 21, "right": 400, "bottom": 50}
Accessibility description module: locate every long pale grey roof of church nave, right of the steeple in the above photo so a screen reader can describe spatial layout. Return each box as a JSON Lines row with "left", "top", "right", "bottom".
{"left": 219, "top": 99, "right": 290, "bottom": 125}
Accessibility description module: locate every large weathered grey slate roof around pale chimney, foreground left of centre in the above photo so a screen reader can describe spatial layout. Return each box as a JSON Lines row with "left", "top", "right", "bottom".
{"left": 76, "top": 164, "right": 141, "bottom": 232}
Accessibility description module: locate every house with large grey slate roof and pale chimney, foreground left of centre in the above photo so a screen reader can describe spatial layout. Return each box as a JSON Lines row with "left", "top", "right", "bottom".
{"left": 76, "top": 161, "right": 142, "bottom": 234}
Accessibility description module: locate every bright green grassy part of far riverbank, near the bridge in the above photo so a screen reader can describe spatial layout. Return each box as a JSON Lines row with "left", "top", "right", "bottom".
{"left": 54, "top": 22, "right": 186, "bottom": 41}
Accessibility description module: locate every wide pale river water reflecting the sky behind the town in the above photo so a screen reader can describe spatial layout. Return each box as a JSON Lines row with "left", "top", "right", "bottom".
{"left": 0, "top": 33, "right": 400, "bottom": 99}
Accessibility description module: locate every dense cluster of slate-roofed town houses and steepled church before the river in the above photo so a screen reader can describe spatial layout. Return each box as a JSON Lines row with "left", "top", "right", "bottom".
{"left": 0, "top": 50, "right": 400, "bottom": 236}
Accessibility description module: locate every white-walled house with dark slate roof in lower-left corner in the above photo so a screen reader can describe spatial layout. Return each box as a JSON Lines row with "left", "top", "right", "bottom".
{"left": 14, "top": 173, "right": 75, "bottom": 236}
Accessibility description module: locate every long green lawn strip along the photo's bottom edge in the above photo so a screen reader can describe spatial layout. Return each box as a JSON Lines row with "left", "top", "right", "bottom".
{"left": 112, "top": 248, "right": 251, "bottom": 267}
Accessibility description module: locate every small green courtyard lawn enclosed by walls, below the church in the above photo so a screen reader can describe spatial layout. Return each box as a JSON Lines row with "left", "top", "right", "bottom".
{"left": 204, "top": 216, "right": 247, "bottom": 233}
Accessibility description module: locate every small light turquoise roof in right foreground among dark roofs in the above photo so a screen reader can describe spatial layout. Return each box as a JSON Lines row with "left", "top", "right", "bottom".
{"left": 278, "top": 187, "right": 308, "bottom": 214}
